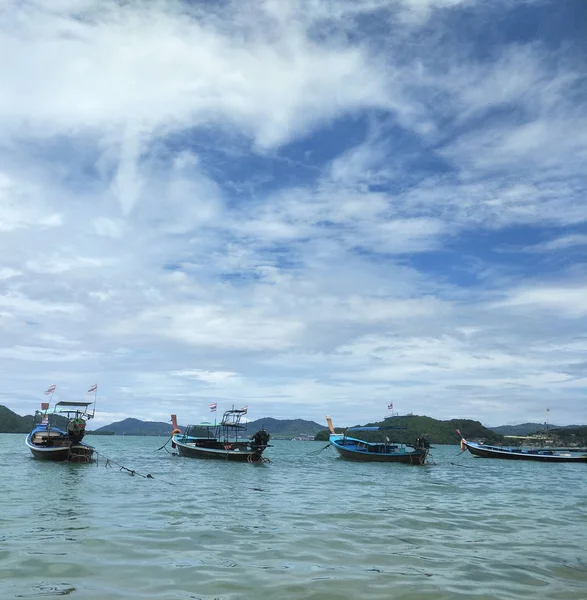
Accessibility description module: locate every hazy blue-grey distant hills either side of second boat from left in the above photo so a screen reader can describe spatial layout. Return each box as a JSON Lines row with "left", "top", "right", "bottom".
{"left": 95, "top": 417, "right": 324, "bottom": 439}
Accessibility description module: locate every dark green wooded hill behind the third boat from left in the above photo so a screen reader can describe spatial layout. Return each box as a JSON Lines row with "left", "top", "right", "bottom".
{"left": 316, "top": 415, "right": 502, "bottom": 444}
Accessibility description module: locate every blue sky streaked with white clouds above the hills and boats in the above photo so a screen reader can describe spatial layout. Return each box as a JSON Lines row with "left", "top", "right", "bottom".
{"left": 0, "top": 0, "right": 587, "bottom": 427}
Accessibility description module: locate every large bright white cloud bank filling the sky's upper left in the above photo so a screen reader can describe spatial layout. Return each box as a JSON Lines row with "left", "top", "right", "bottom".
{"left": 0, "top": 2, "right": 396, "bottom": 146}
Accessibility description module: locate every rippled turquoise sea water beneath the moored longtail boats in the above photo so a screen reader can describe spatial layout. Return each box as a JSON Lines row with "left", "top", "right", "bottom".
{"left": 0, "top": 434, "right": 587, "bottom": 600}
